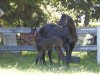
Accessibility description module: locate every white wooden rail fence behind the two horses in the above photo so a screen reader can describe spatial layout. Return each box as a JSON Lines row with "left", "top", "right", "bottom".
{"left": 0, "top": 27, "right": 100, "bottom": 64}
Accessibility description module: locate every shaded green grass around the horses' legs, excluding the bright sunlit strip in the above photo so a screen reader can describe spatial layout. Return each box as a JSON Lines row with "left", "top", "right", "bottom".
{"left": 0, "top": 52, "right": 100, "bottom": 73}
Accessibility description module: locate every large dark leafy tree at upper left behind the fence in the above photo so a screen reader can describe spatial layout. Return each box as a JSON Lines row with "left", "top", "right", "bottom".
{"left": 0, "top": 0, "right": 46, "bottom": 27}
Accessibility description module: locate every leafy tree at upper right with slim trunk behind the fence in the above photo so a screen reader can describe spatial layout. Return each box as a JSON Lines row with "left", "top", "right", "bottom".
{"left": 61, "top": 0, "right": 100, "bottom": 27}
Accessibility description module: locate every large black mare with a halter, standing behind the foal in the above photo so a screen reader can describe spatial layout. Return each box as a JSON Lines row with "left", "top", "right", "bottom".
{"left": 40, "top": 14, "right": 77, "bottom": 65}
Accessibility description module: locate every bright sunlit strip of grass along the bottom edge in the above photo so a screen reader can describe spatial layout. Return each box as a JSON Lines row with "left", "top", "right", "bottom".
{"left": 0, "top": 68, "right": 96, "bottom": 75}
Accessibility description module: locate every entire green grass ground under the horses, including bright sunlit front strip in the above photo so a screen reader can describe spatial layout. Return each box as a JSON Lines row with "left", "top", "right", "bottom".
{"left": 0, "top": 52, "right": 100, "bottom": 75}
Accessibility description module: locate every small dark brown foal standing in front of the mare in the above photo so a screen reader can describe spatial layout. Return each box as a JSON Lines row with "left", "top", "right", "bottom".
{"left": 34, "top": 30, "right": 64, "bottom": 64}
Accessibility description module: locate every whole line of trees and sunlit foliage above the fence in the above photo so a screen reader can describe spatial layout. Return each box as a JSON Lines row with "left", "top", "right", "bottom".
{"left": 0, "top": 0, "right": 100, "bottom": 27}
